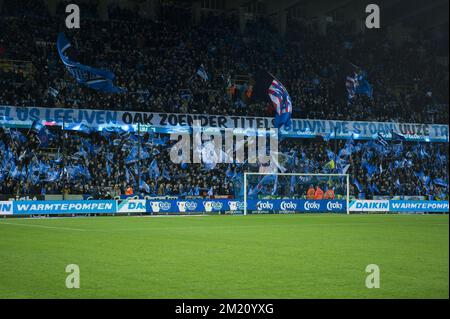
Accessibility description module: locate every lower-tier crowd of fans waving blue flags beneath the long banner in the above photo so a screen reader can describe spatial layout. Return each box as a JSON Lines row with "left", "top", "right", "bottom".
{"left": 0, "top": 128, "right": 449, "bottom": 199}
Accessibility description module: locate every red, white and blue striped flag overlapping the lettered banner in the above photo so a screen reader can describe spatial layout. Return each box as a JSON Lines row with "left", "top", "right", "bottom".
{"left": 252, "top": 69, "right": 292, "bottom": 128}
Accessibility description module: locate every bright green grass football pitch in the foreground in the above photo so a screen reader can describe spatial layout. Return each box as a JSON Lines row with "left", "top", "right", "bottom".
{"left": 0, "top": 214, "right": 449, "bottom": 298}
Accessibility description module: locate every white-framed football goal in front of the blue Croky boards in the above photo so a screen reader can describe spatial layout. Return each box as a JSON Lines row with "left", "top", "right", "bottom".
{"left": 243, "top": 172, "right": 350, "bottom": 215}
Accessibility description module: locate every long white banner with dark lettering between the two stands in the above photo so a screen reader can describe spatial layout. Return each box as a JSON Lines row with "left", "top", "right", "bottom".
{"left": 0, "top": 105, "right": 449, "bottom": 142}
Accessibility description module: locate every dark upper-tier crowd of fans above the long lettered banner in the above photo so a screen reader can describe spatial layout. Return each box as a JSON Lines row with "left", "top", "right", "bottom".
{"left": 0, "top": 0, "right": 448, "bottom": 123}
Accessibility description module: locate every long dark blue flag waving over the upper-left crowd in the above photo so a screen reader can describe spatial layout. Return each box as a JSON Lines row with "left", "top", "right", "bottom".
{"left": 56, "top": 33, "right": 125, "bottom": 93}
